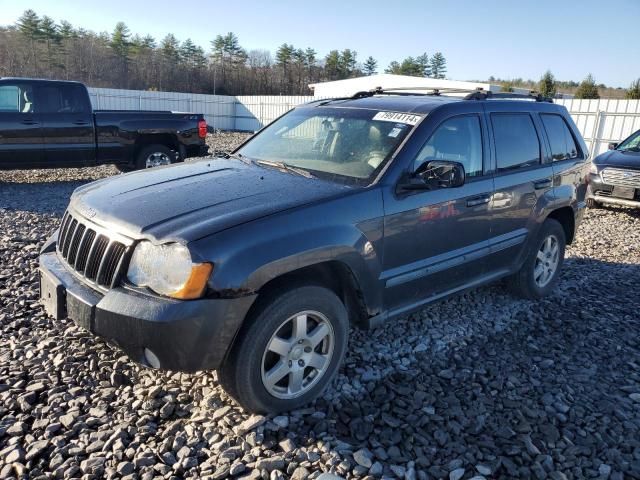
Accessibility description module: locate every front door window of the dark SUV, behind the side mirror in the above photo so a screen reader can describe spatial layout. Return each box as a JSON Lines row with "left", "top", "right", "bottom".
{"left": 414, "top": 115, "right": 482, "bottom": 177}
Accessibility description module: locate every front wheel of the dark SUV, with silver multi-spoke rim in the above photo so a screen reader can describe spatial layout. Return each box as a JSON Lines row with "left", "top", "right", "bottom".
{"left": 218, "top": 286, "right": 349, "bottom": 413}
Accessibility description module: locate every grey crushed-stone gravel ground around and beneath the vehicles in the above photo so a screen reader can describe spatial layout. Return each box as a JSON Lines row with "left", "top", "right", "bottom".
{"left": 0, "top": 134, "right": 640, "bottom": 480}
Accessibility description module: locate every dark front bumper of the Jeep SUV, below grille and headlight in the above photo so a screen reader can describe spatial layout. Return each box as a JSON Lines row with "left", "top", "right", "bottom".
{"left": 40, "top": 252, "right": 256, "bottom": 372}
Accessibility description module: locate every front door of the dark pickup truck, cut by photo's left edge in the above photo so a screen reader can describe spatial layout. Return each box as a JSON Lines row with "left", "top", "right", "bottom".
{"left": 0, "top": 81, "right": 43, "bottom": 168}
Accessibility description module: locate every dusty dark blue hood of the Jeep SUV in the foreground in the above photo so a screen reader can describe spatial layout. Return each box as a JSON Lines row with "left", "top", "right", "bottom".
{"left": 70, "top": 159, "right": 352, "bottom": 242}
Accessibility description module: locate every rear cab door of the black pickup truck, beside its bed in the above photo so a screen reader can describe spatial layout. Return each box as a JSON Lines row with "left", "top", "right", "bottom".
{"left": 36, "top": 82, "right": 96, "bottom": 167}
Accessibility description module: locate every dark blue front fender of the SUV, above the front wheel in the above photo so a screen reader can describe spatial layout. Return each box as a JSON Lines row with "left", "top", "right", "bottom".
{"left": 192, "top": 191, "right": 383, "bottom": 312}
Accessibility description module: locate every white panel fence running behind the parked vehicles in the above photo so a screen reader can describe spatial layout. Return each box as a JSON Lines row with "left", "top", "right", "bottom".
{"left": 89, "top": 88, "right": 640, "bottom": 156}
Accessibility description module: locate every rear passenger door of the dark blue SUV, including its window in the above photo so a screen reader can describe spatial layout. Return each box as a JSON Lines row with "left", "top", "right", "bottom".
{"left": 485, "top": 102, "right": 554, "bottom": 269}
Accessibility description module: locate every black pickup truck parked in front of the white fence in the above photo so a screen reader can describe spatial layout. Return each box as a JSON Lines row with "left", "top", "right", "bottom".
{"left": 0, "top": 78, "right": 208, "bottom": 171}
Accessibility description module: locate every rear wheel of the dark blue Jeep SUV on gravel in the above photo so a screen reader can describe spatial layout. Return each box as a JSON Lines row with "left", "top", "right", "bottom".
{"left": 507, "top": 218, "right": 566, "bottom": 300}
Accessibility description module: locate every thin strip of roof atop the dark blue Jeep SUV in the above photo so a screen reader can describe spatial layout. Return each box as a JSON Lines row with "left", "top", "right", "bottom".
{"left": 301, "top": 94, "right": 562, "bottom": 113}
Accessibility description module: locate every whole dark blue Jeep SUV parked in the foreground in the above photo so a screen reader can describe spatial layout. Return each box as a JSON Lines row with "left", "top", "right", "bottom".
{"left": 40, "top": 91, "right": 589, "bottom": 412}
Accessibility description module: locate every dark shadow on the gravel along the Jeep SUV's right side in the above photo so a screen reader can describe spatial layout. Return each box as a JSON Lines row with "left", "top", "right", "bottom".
{"left": 284, "top": 258, "right": 640, "bottom": 478}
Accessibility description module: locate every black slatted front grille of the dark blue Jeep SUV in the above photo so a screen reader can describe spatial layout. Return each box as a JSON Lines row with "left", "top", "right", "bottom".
{"left": 57, "top": 211, "right": 131, "bottom": 290}
